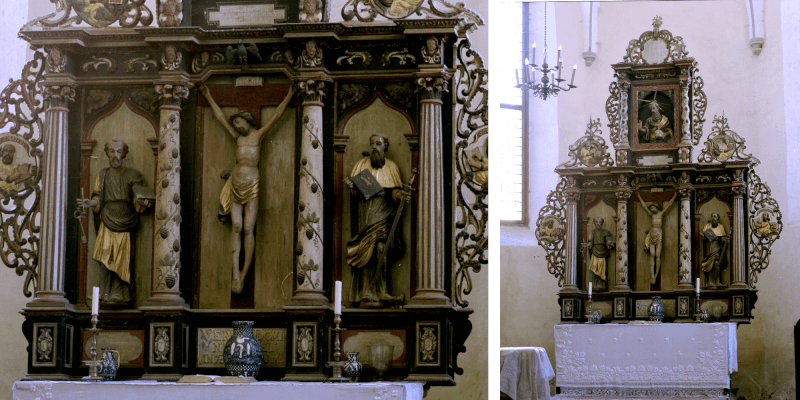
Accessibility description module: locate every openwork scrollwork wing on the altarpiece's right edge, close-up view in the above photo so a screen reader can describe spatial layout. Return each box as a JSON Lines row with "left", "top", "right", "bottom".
{"left": 453, "top": 39, "right": 489, "bottom": 307}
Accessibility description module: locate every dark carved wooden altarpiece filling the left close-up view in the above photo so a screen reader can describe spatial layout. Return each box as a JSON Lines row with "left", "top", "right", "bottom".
{"left": 0, "top": 0, "right": 488, "bottom": 385}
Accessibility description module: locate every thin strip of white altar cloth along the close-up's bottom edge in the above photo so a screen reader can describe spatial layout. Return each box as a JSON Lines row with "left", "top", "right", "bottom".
{"left": 14, "top": 381, "right": 423, "bottom": 400}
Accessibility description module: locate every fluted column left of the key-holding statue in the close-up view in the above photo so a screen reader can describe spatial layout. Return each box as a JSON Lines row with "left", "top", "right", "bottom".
{"left": 27, "top": 82, "right": 75, "bottom": 307}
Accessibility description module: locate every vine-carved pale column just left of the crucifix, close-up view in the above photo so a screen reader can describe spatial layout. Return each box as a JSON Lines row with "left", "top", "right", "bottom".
{"left": 145, "top": 83, "right": 193, "bottom": 307}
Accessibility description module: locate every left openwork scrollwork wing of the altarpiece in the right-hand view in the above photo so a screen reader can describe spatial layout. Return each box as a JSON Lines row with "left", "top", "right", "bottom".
{"left": 536, "top": 178, "right": 567, "bottom": 287}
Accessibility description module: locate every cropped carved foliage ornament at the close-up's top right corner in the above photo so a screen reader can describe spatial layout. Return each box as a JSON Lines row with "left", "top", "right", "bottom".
{"left": 342, "top": 0, "right": 483, "bottom": 33}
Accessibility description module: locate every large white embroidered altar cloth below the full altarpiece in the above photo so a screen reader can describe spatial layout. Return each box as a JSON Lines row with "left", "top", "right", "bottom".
{"left": 555, "top": 323, "right": 738, "bottom": 398}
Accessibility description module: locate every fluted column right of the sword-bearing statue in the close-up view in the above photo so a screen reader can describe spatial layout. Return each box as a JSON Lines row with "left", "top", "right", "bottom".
{"left": 411, "top": 76, "right": 450, "bottom": 305}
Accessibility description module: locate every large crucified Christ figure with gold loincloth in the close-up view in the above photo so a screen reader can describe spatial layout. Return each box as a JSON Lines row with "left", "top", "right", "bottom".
{"left": 199, "top": 85, "right": 296, "bottom": 294}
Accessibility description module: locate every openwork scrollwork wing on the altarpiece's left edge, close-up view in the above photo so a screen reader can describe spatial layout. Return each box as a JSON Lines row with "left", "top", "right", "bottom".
{"left": 0, "top": 51, "right": 45, "bottom": 297}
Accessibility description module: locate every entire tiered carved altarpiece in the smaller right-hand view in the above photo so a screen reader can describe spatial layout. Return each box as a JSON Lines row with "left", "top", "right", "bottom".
{"left": 536, "top": 17, "right": 783, "bottom": 323}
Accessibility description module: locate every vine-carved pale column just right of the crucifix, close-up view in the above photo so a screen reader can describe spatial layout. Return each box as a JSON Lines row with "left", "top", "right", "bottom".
{"left": 290, "top": 80, "right": 332, "bottom": 305}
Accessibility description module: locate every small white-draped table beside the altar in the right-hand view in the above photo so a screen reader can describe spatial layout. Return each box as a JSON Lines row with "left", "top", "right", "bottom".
{"left": 500, "top": 347, "right": 556, "bottom": 400}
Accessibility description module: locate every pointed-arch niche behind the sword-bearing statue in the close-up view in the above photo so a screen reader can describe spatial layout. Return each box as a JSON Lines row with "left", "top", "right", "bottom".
{"left": 334, "top": 93, "right": 418, "bottom": 307}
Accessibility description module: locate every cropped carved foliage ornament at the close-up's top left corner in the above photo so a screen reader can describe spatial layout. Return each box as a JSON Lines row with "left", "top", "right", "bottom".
{"left": 21, "top": 0, "right": 153, "bottom": 32}
